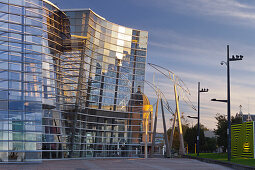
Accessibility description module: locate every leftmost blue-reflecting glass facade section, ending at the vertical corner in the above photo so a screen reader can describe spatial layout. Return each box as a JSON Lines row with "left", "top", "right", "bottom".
{"left": 0, "top": 0, "right": 43, "bottom": 162}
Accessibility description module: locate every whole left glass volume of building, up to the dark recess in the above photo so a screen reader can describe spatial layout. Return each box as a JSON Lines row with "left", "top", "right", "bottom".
{"left": 0, "top": 0, "right": 69, "bottom": 162}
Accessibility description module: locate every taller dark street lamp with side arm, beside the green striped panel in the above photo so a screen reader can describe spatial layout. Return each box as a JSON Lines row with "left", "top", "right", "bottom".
{"left": 211, "top": 45, "right": 243, "bottom": 161}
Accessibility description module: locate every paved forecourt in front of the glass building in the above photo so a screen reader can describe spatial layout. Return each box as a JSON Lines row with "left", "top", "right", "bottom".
{"left": 0, "top": 158, "right": 230, "bottom": 170}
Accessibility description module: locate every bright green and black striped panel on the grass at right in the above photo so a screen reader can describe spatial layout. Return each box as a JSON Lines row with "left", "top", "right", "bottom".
{"left": 231, "top": 122, "right": 255, "bottom": 158}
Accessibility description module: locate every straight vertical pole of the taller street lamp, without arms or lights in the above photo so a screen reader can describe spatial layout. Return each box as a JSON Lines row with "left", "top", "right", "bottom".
{"left": 227, "top": 45, "right": 231, "bottom": 161}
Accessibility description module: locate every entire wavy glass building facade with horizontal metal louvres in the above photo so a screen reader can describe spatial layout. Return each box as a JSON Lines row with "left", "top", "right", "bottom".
{"left": 0, "top": 0, "right": 148, "bottom": 162}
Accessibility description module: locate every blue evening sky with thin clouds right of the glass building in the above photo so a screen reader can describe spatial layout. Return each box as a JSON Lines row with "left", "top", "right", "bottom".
{"left": 51, "top": 0, "right": 255, "bottom": 132}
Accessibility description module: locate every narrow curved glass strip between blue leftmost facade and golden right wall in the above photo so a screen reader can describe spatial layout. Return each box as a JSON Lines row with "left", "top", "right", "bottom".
{"left": 42, "top": 1, "right": 70, "bottom": 159}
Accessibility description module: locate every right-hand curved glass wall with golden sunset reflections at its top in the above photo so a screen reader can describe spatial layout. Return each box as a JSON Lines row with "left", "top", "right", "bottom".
{"left": 64, "top": 10, "right": 148, "bottom": 157}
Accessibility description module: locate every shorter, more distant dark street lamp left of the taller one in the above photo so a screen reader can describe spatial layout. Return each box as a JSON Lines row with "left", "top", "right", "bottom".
{"left": 197, "top": 82, "right": 209, "bottom": 156}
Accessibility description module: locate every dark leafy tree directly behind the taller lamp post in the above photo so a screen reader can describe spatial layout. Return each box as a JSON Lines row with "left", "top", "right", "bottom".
{"left": 214, "top": 113, "right": 242, "bottom": 152}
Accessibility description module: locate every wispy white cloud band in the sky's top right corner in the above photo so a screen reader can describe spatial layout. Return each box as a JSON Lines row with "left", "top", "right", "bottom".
{"left": 133, "top": 0, "right": 255, "bottom": 27}
